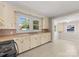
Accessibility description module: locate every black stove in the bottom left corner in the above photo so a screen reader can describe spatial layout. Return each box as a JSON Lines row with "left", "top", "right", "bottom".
{"left": 0, "top": 40, "right": 17, "bottom": 57}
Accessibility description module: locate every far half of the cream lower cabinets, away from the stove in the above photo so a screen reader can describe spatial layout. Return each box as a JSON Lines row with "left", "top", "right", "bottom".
{"left": 31, "top": 33, "right": 51, "bottom": 48}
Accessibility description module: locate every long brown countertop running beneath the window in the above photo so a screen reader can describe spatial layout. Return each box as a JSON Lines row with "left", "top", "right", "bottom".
{"left": 0, "top": 32, "right": 50, "bottom": 41}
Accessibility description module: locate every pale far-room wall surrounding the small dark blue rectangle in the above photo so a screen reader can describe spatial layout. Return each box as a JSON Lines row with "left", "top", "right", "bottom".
{"left": 59, "top": 21, "right": 79, "bottom": 40}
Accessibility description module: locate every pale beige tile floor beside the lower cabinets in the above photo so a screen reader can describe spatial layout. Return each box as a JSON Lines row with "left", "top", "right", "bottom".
{"left": 18, "top": 40, "right": 79, "bottom": 57}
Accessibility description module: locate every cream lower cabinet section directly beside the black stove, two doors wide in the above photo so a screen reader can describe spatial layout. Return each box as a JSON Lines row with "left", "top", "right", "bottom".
{"left": 14, "top": 37, "right": 30, "bottom": 53}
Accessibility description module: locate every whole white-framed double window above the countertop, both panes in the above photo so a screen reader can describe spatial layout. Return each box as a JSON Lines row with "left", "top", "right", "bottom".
{"left": 16, "top": 14, "right": 40, "bottom": 33}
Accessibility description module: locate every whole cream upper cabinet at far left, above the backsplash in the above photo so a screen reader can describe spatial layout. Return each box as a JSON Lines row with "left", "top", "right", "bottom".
{"left": 0, "top": 4, "right": 15, "bottom": 29}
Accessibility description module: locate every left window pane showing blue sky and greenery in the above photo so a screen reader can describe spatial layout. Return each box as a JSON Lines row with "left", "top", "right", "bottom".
{"left": 16, "top": 15, "right": 29, "bottom": 32}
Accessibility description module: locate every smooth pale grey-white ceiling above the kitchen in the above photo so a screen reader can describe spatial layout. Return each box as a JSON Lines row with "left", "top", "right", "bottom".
{"left": 4, "top": 1, "right": 79, "bottom": 17}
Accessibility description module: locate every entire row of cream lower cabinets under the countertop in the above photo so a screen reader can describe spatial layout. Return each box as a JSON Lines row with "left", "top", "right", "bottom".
{"left": 14, "top": 33, "right": 51, "bottom": 53}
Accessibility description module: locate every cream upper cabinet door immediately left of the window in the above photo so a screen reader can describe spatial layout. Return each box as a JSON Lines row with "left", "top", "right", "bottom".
{"left": 3, "top": 4, "right": 15, "bottom": 29}
